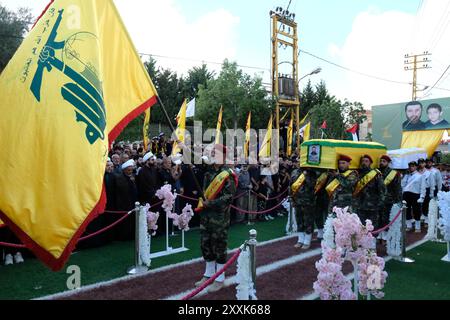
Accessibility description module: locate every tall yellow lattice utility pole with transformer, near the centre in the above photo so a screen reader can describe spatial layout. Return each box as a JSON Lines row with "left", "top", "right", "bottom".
{"left": 270, "top": 7, "right": 300, "bottom": 154}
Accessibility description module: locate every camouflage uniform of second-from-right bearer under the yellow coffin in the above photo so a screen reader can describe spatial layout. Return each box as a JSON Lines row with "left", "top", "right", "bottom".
{"left": 354, "top": 169, "right": 386, "bottom": 229}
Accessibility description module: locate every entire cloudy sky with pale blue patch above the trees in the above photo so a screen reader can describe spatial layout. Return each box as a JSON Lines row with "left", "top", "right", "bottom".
{"left": 0, "top": 0, "right": 450, "bottom": 108}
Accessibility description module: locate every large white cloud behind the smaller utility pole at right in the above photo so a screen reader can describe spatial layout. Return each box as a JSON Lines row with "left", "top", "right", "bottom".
{"left": 327, "top": 1, "right": 450, "bottom": 108}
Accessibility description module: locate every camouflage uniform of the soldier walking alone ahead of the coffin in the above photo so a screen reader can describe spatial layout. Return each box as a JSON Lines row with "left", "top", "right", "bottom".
{"left": 200, "top": 167, "right": 237, "bottom": 264}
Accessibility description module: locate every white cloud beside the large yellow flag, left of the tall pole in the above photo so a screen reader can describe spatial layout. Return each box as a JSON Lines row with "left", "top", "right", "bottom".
{"left": 115, "top": 0, "right": 239, "bottom": 73}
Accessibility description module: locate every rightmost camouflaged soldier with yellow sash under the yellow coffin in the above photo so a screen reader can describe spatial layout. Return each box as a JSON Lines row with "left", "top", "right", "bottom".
{"left": 379, "top": 155, "right": 402, "bottom": 240}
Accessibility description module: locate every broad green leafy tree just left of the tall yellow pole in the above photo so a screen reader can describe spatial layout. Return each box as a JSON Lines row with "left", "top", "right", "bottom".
{"left": 196, "top": 60, "right": 273, "bottom": 129}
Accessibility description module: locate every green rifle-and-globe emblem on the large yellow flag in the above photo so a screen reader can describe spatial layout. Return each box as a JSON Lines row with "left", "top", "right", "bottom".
{"left": 30, "top": 10, "right": 106, "bottom": 144}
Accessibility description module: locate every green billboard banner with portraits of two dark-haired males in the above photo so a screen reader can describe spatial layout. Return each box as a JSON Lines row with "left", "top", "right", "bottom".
{"left": 372, "top": 98, "right": 450, "bottom": 150}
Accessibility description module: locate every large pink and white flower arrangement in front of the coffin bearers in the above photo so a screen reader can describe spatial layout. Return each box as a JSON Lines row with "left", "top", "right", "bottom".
{"left": 314, "top": 208, "right": 387, "bottom": 300}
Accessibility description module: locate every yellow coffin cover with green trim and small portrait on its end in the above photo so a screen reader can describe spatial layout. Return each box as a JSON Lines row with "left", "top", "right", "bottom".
{"left": 300, "top": 140, "right": 387, "bottom": 169}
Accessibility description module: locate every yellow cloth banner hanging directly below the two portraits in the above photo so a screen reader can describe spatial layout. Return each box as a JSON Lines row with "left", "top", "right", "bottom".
{"left": 402, "top": 130, "right": 446, "bottom": 158}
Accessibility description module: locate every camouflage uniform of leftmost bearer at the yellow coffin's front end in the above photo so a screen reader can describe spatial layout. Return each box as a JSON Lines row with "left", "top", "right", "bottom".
{"left": 292, "top": 169, "right": 317, "bottom": 235}
